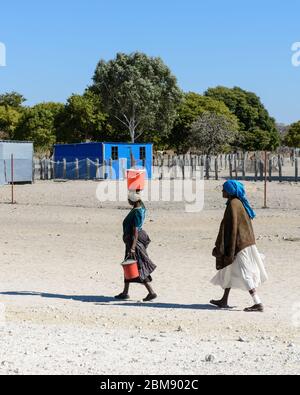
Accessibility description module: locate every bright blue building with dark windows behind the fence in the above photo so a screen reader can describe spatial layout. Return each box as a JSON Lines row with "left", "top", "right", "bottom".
{"left": 53, "top": 142, "right": 153, "bottom": 180}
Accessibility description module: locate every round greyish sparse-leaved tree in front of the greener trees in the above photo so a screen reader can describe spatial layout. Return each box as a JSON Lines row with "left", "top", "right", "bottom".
{"left": 190, "top": 112, "right": 236, "bottom": 155}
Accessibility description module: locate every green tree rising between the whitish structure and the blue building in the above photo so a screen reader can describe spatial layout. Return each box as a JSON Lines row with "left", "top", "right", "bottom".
{"left": 15, "top": 103, "right": 64, "bottom": 152}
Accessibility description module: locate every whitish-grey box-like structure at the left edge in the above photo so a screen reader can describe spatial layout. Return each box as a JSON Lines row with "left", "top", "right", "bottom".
{"left": 0, "top": 140, "right": 33, "bottom": 185}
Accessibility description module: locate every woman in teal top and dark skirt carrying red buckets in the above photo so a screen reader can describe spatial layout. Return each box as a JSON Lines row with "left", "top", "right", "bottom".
{"left": 115, "top": 191, "right": 157, "bottom": 302}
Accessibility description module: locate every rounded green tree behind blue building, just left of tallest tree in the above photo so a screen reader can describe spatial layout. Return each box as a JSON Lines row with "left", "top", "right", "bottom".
{"left": 55, "top": 91, "right": 111, "bottom": 143}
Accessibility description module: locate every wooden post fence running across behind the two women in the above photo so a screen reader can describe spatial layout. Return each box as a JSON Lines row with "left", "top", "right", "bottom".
{"left": 34, "top": 151, "right": 300, "bottom": 182}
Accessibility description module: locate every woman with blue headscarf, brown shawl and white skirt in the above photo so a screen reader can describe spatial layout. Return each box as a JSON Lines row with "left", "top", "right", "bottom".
{"left": 211, "top": 180, "right": 268, "bottom": 312}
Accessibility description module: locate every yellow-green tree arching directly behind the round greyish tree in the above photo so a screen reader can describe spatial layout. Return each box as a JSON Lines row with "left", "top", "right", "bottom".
{"left": 168, "top": 92, "right": 238, "bottom": 153}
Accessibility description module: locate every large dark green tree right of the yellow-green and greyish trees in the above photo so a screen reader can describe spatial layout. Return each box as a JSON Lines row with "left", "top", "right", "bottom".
{"left": 205, "top": 86, "right": 280, "bottom": 150}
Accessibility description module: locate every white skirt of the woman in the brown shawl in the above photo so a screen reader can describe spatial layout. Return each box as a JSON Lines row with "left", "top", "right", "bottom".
{"left": 211, "top": 245, "right": 268, "bottom": 291}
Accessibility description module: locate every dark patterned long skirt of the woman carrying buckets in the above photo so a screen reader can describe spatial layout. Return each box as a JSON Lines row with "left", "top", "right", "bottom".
{"left": 123, "top": 230, "right": 156, "bottom": 284}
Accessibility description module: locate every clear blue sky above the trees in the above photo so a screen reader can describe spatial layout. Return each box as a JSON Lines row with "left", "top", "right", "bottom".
{"left": 0, "top": 0, "right": 300, "bottom": 123}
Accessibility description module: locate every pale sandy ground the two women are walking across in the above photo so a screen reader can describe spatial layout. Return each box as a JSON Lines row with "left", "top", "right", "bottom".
{"left": 0, "top": 181, "right": 300, "bottom": 375}
